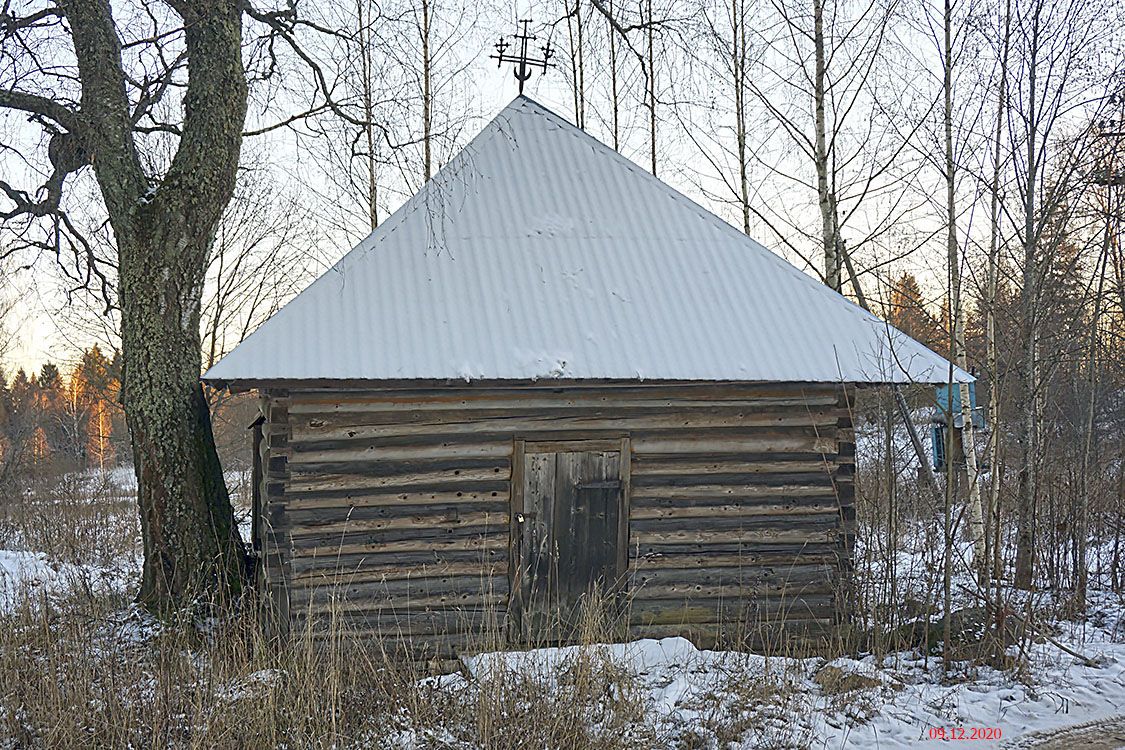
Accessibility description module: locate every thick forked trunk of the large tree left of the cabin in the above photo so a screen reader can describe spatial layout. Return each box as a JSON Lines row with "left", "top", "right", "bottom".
{"left": 59, "top": 0, "right": 255, "bottom": 612}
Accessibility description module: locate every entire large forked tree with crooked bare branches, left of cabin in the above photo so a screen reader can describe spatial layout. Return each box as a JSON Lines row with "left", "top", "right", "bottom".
{"left": 0, "top": 0, "right": 382, "bottom": 612}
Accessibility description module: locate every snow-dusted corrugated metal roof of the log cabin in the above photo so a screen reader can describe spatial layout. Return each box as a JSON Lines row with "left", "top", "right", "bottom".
{"left": 205, "top": 97, "right": 963, "bottom": 382}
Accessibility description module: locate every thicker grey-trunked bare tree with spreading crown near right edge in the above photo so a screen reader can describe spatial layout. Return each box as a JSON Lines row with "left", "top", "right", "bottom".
{"left": 1006, "top": 0, "right": 1115, "bottom": 588}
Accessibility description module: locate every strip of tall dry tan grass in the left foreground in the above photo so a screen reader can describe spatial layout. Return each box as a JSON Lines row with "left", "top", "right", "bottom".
{"left": 0, "top": 597, "right": 665, "bottom": 750}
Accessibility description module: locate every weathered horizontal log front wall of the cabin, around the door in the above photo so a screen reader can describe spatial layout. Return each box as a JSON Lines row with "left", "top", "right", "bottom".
{"left": 259, "top": 383, "right": 855, "bottom": 652}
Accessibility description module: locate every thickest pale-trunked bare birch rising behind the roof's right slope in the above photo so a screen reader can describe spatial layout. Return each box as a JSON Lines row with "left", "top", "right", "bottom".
{"left": 746, "top": 0, "right": 935, "bottom": 291}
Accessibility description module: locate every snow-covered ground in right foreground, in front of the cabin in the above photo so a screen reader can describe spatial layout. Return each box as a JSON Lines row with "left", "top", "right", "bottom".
{"left": 387, "top": 611, "right": 1125, "bottom": 750}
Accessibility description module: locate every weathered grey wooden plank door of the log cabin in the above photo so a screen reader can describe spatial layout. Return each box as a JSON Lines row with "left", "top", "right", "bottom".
{"left": 513, "top": 442, "right": 628, "bottom": 640}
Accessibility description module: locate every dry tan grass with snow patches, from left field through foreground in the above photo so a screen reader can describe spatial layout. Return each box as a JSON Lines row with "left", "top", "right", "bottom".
{"left": 0, "top": 478, "right": 819, "bottom": 750}
